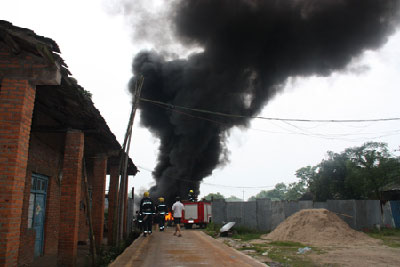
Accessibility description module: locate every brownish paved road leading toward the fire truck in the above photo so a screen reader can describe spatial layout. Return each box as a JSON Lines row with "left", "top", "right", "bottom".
{"left": 110, "top": 229, "right": 266, "bottom": 267}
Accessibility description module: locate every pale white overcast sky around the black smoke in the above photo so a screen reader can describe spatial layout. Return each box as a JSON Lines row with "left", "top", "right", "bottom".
{"left": 0, "top": 0, "right": 400, "bottom": 199}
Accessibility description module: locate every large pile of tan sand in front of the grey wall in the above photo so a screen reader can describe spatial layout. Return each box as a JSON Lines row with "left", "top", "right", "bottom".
{"left": 262, "top": 209, "right": 378, "bottom": 245}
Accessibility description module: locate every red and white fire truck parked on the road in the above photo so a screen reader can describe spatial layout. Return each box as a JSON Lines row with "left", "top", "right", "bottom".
{"left": 182, "top": 201, "right": 211, "bottom": 229}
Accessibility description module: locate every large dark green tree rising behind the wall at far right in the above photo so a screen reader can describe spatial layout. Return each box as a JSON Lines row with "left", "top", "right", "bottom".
{"left": 296, "top": 142, "right": 400, "bottom": 201}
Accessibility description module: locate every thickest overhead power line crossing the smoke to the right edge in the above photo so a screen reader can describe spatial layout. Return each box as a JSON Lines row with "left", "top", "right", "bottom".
{"left": 140, "top": 97, "right": 400, "bottom": 123}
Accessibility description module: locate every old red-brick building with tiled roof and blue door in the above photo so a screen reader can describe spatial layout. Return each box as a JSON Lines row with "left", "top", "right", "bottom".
{"left": 0, "top": 21, "right": 137, "bottom": 266}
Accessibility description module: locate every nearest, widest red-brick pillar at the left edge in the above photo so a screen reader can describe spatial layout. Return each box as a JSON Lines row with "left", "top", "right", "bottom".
{"left": 0, "top": 78, "right": 35, "bottom": 266}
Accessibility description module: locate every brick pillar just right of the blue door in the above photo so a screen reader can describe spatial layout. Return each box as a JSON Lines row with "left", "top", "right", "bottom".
{"left": 58, "top": 131, "right": 84, "bottom": 266}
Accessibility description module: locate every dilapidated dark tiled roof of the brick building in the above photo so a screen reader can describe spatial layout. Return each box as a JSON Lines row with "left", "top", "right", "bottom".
{"left": 0, "top": 20, "right": 137, "bottom": 175}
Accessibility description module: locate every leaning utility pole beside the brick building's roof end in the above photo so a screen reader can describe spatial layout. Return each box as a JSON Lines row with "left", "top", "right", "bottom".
{"left": 113, "top": 76, "right": 144, "bottom": 244}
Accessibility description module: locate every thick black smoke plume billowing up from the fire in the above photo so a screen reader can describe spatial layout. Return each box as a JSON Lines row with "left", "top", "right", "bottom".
{"left": 131, "top": 0, "right": 399, "bottom": 203}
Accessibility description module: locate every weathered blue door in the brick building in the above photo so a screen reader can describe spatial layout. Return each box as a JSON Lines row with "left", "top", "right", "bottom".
{"left": 29, "top": 174, "right": 48, "bottom": 257}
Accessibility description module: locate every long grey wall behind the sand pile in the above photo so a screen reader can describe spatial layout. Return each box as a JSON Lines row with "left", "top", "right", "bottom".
{"left": 212, "top": 199, "right": 395, "bottom": 231}
